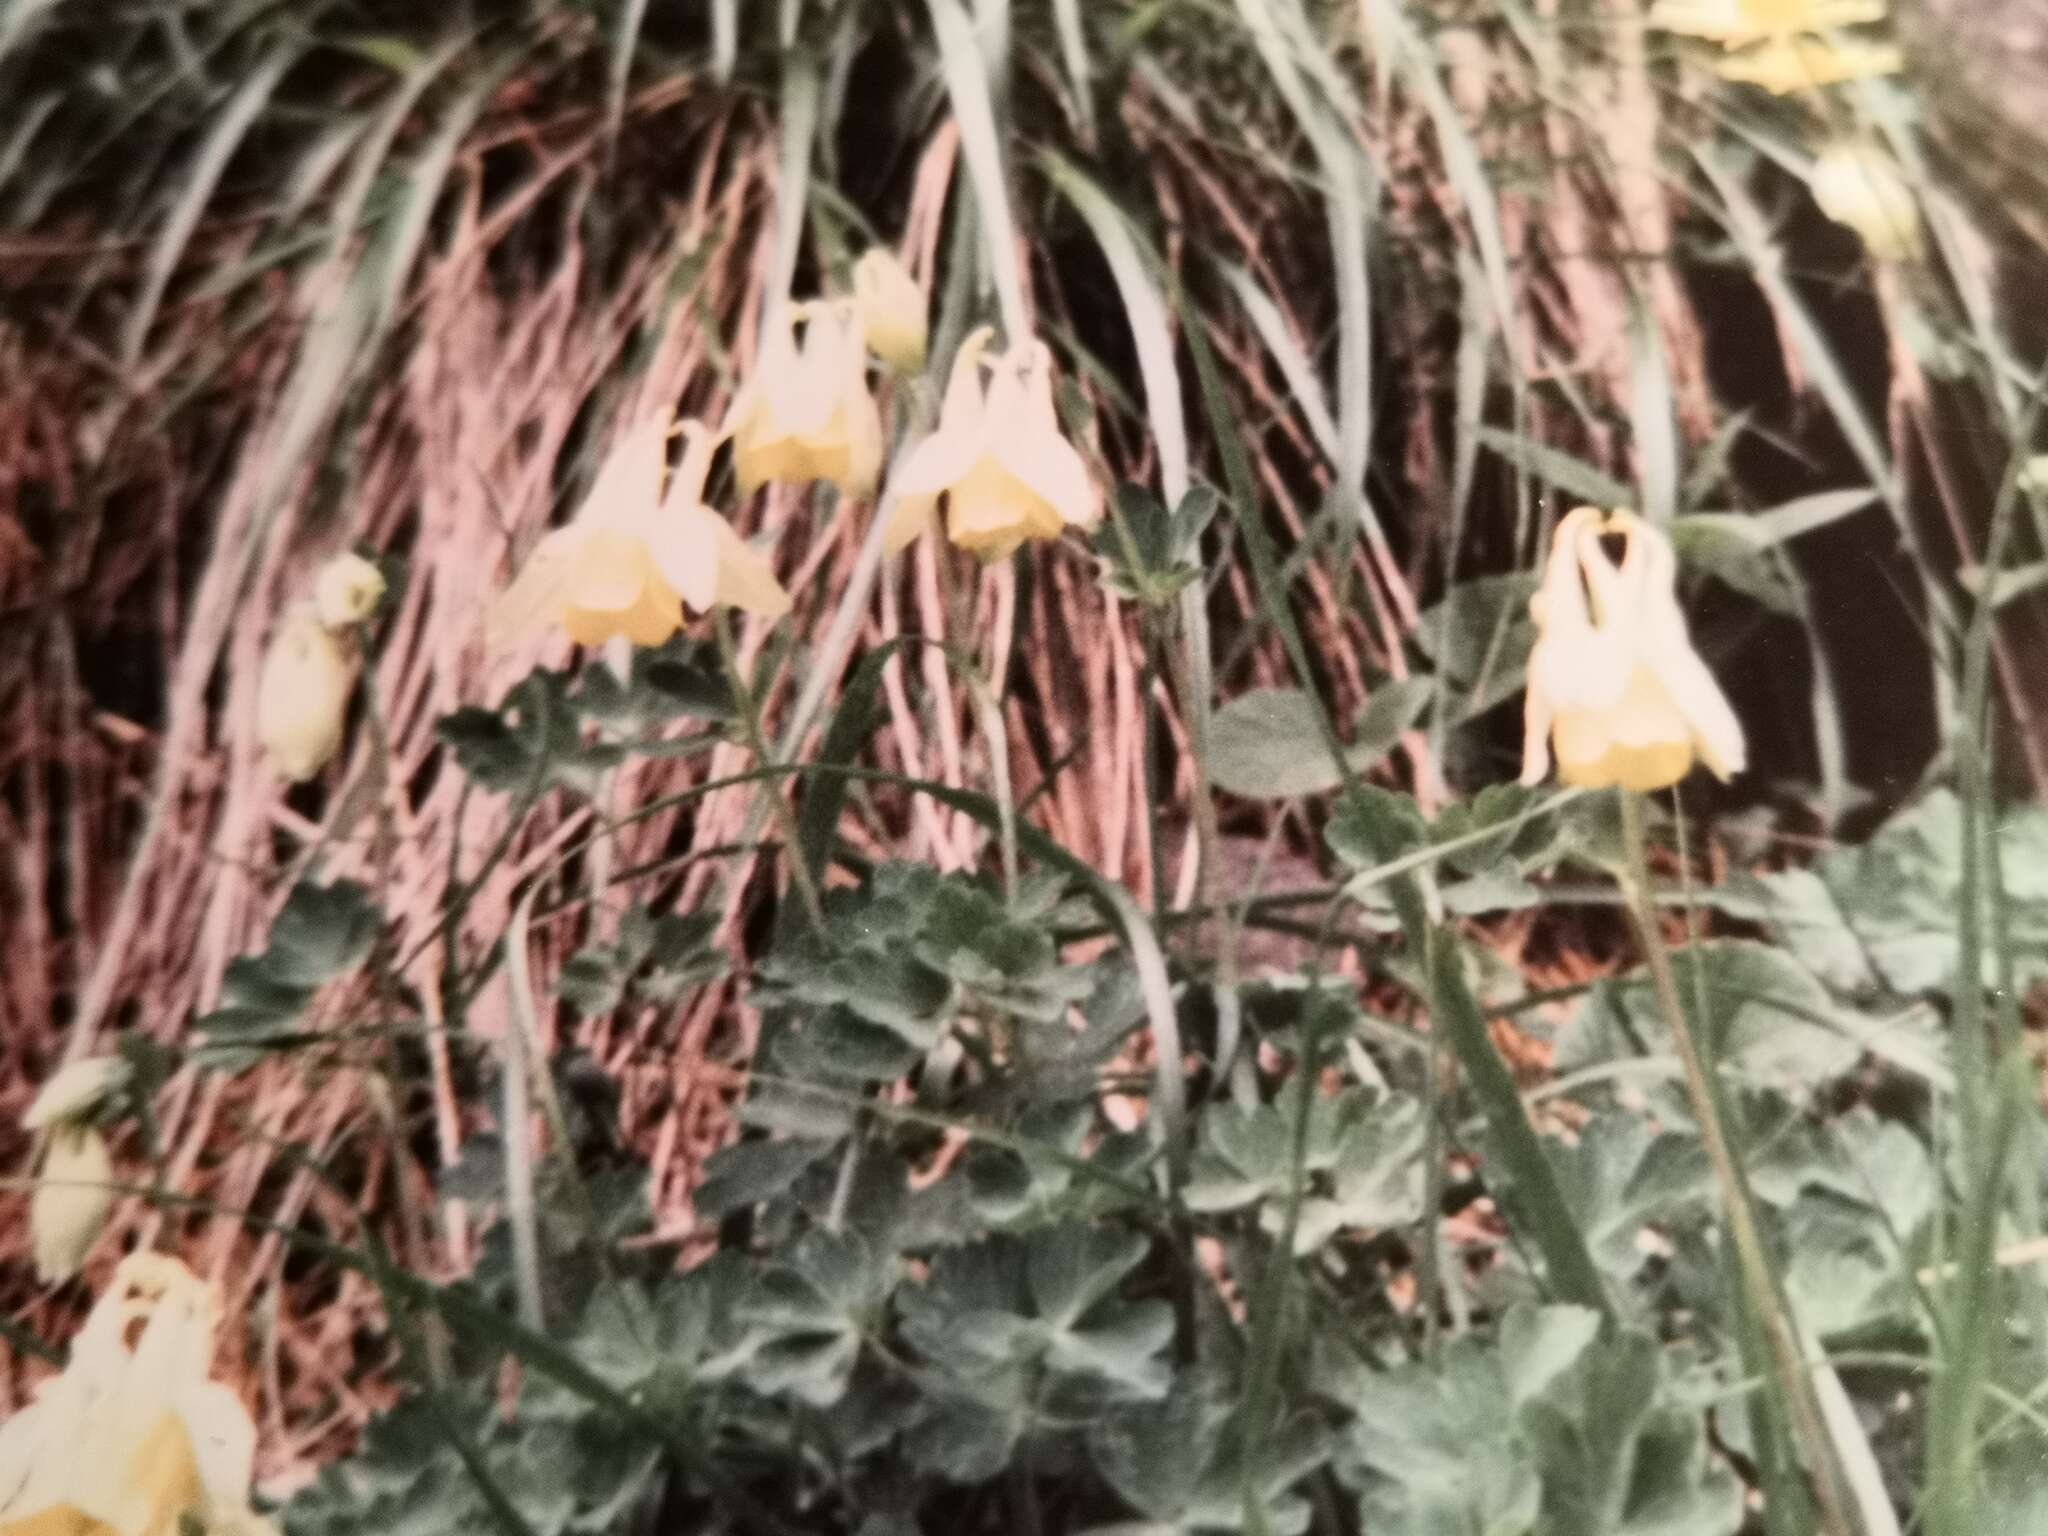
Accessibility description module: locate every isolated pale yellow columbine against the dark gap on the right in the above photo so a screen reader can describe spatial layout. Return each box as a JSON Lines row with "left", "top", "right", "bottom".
{"left": 1522, "top": 506, "right": 1743, "bottom": 791}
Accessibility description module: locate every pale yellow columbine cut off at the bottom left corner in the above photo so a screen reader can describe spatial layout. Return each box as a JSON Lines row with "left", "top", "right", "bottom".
{"left": 0, "top": 1253, "right": 274, "bottom": 1536}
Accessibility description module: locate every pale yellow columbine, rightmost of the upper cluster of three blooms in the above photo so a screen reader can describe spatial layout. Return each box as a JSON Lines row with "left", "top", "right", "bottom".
{"left": 887, "top": 326, "right": 1102, "bottom": 561}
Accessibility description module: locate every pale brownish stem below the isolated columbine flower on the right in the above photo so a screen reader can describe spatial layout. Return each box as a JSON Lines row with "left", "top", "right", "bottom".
{"left": 1616, "top": 791, "right": 1862, "bottom": 1536}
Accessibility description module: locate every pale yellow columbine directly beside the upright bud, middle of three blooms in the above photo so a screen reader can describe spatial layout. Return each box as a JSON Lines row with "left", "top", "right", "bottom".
{"left": 729, "top": 299, "right": 883, "bottom": 502}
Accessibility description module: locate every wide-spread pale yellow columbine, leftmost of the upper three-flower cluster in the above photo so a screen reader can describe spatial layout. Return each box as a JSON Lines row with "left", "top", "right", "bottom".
{"left": 483, "top": 418, "right": 788, "bottom": 649}
